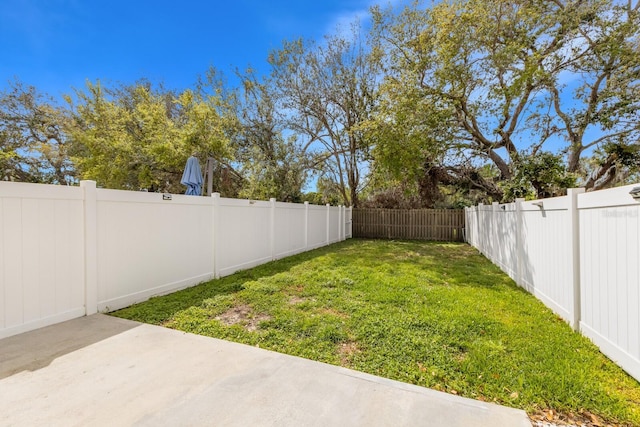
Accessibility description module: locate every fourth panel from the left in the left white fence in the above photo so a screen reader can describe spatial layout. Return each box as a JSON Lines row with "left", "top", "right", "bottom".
{"left": 274, "top": 202, "right": 307, "bottom": 258}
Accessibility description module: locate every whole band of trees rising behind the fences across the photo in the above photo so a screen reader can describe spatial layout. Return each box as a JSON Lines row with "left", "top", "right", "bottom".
{"left": 0, "top": 0, "right": 640, "bottom": 207}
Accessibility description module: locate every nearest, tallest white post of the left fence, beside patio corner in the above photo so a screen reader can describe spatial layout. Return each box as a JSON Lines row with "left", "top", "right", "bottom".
{"left": 80, "top": 181, "right": 98, "bottom": 316}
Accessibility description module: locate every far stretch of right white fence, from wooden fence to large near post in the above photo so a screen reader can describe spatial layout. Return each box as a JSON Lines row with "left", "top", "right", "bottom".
{"left": 465, "top": 196, "right": 573, "bottom": 322}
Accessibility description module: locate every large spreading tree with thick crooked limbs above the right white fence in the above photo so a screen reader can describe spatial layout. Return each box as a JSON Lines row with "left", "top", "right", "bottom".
{"left": 368, "top": 0, "right": 640, "bottom": 205}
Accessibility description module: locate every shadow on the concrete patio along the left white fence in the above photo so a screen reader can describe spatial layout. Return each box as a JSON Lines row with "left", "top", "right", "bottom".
{"left": 0, "top": 315, "right": 140, "bottom": 380}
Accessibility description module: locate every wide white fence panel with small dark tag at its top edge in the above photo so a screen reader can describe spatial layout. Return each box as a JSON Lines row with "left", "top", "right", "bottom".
{"left": 97, "top": 189, "right": 213, "bottom": 311}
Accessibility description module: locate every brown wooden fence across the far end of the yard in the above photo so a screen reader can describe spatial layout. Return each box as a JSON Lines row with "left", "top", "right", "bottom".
{"left": 352, "top": 209, "right": 464, "bottom": 242}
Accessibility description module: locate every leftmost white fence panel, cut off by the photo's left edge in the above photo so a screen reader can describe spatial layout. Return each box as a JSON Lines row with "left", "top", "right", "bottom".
{"left": 0, "top": 182, "right": 85, "bottom": 338}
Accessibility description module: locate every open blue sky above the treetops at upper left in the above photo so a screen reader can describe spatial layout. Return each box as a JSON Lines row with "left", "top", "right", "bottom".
{"left": 0, "top": 0, "right": 400, "bottom": 97}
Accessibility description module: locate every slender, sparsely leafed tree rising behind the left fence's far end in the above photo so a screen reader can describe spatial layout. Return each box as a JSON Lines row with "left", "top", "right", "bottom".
{"left": 269, "top": 26, "right": 380, "bottom": 206}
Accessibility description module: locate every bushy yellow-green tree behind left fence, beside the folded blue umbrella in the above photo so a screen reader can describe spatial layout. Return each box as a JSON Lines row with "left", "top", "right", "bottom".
{"left": 70, "top": 81, "right": 233, "bottom": 193}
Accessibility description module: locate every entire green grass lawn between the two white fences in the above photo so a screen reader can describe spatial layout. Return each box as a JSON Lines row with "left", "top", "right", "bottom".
{"left": 112, "top": 239, "right": 640, "bottom": 425}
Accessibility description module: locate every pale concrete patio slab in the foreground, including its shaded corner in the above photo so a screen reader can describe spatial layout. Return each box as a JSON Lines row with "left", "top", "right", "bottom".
{"left": 0, "top": 315, "right": 531, "bottom": 427}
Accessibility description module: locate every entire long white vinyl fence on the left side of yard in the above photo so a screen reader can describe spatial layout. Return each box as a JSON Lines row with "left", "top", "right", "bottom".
{"left": 0, "top": 181, "right": 351, "bottom": 338}
